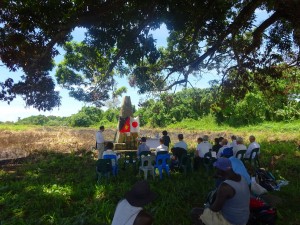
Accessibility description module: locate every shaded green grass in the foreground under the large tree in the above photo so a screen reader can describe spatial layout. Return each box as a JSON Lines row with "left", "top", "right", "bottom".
{"left": 0, "top": 141, "right": 300, "bottom": 225}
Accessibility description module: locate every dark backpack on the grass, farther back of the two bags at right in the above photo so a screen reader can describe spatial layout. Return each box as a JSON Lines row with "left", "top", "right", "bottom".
{"left": 255, "top": 168, "right": 278, "bottom": 191}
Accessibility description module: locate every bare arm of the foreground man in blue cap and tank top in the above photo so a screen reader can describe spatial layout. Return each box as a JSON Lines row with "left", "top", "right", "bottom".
{"left": 210, "top": 183, "right": 235, "bottom": 212}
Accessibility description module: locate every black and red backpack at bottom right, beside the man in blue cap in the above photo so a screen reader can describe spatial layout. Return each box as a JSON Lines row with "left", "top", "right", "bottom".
{"left": 247, "top": 197, "right": 277, "bottom": 225}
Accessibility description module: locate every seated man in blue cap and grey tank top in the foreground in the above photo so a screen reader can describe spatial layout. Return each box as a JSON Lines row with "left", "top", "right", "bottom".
{"left": 193, "top": 158, "right": 250, "bottom": 225}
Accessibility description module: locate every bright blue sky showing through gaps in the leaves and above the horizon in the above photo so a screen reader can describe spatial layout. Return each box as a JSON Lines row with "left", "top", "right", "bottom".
{"left": 0, "top": 25, "right": 217, "bottom": 122}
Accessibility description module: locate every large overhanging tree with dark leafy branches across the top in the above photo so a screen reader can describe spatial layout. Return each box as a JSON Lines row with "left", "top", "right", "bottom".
{"left": 0, "top": 0, "right": 300, "bottom": 110}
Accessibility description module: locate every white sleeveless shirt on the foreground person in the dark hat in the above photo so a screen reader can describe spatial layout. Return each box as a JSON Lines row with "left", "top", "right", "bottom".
{"left": 111, "top": 199, "right": 143, "bottom": 225}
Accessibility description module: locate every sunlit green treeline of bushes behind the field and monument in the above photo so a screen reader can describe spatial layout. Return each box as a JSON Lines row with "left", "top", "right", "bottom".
{"left": 1, "top": 87, "right": 300, "bottom": 127}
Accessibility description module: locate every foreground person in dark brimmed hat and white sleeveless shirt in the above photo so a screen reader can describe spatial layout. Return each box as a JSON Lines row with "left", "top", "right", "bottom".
{"left": 112, "top": 181, "right": 156, "bottom": 225}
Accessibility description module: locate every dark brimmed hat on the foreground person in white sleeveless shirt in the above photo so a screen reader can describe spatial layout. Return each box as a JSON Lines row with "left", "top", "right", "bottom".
{"left": 125, "top": 180, "right": 156, "bottom": 207}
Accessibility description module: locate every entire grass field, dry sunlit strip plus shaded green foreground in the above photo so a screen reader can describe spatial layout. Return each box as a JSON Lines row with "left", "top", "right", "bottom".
{"left": 0, "top": 122, "right": 300, "bottom": 225}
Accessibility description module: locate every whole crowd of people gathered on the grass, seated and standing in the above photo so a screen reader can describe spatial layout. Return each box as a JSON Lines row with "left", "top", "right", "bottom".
{"left": 96, "top": 126, "right": 260, "bottom": 225}
